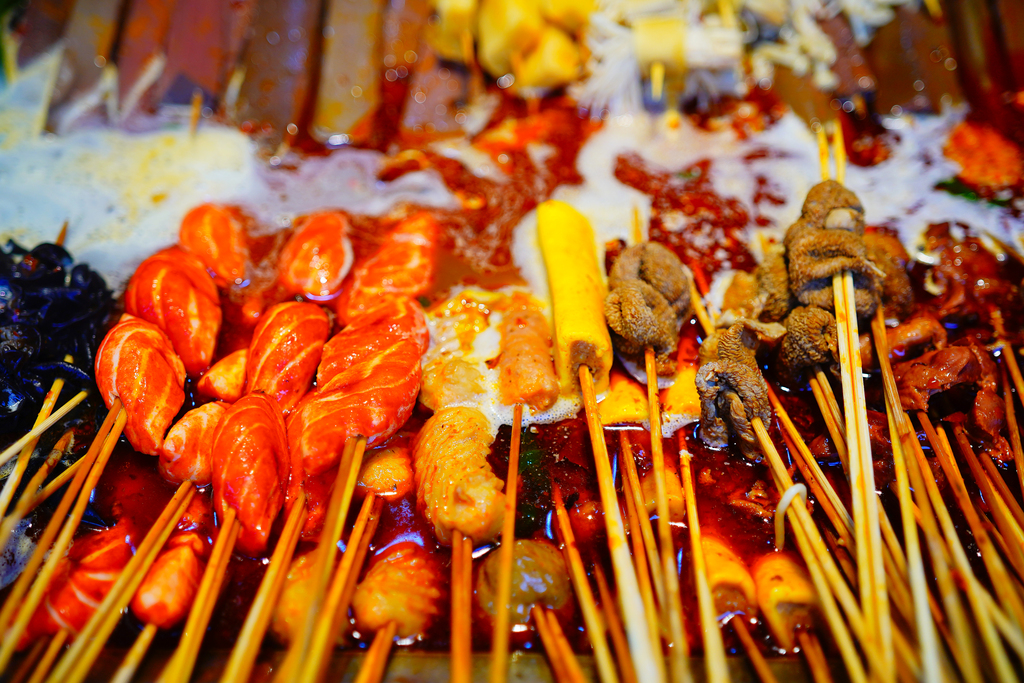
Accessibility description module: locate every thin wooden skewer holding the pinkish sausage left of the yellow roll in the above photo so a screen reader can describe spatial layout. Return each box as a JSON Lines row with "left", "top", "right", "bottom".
{"left": 490, "top": 403, "right": 522, "bottom": 683}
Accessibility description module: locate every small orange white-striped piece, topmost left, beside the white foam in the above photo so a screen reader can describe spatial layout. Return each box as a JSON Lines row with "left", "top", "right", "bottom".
{"left": 178, "top": 204, "right": 249, "bottom": 287}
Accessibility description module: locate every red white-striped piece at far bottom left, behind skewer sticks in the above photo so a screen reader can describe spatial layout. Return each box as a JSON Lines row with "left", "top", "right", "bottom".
{"left": 22, "top": 520, "right": 134, "bottom": 644}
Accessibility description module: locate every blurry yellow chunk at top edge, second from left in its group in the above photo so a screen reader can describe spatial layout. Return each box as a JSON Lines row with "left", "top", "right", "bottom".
{"left": 476, "top": 0, "right": 544, "bottom": 78}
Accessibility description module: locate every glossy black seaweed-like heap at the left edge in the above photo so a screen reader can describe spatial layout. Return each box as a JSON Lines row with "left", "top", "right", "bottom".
{"left": 0, "top": 241, "right": 113, "bottom": 433}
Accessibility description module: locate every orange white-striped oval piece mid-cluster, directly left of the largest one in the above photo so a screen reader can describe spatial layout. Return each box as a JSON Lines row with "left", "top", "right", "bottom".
{"left": 246, "top": 301, "right": 331, "bottom": 414}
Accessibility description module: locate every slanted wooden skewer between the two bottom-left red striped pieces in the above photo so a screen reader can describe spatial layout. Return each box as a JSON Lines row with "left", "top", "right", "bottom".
{"left": 47, "top": 481, "right": 196, "bottom": 683}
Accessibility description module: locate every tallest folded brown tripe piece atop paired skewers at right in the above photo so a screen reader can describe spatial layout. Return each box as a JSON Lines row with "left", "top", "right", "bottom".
{"left": 785, "top": 180, "right": 885, "bottom": 317}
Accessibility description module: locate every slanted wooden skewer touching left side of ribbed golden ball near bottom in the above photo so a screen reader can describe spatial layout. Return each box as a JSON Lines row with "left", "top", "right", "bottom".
{"left": 299, "top": 491, "right": 385, "bottom": 683}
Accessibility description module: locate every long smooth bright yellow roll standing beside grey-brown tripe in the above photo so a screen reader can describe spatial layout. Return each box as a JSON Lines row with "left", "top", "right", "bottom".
{"left": 537, "top": 201, "right": 611, "bottom": 394}
